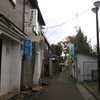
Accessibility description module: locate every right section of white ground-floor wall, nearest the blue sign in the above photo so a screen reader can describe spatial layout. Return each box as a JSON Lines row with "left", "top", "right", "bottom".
{"left": 10, "top": 42, "right": 22, "bottom": 91}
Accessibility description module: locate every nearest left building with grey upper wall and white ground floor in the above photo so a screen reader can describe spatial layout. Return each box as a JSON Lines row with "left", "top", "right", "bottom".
{"left": 0, "top": 0, "right": 27, "bottom": 96}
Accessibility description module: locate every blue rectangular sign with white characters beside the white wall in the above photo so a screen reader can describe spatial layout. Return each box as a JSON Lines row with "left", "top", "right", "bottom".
{"left": 23, "top": 40, "right": 32, "bottom": 55}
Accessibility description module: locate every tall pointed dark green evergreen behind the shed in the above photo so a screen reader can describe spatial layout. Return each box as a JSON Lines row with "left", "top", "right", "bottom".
{"left": 72, "top": 28, "right": 91, "bottom": 53}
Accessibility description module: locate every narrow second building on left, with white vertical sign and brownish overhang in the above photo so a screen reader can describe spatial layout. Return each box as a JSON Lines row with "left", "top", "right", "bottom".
{"left": 21, "top": 0, "right": 50, "bottom": 86}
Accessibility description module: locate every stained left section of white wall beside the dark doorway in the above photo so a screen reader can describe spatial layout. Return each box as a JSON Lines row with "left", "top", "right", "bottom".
{"left": 0, "top": 38, "right": 11, "bottom": 95}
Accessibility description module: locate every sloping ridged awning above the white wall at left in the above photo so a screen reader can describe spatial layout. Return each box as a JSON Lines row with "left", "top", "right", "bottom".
{"left": 0, "top": 14, "right": 27, "bottom": 43}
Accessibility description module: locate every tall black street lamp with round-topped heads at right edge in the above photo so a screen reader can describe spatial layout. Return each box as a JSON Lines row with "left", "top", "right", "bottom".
{"left": 92, "top": 1, "right": 100, "bottom": 92}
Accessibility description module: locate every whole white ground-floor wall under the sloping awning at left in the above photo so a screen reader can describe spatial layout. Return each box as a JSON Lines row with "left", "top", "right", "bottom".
{"left": 0, "top": 38, "right": 21, "bottom": 95}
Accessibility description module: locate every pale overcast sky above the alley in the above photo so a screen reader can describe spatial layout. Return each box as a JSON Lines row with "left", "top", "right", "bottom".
{"left": 38, "top": 0, "right": 100, "bottom": 46}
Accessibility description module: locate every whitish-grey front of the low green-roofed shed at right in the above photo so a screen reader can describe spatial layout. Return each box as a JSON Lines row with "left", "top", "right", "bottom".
{"left": 70, "top": 51, "right": 97, "bottom": 82}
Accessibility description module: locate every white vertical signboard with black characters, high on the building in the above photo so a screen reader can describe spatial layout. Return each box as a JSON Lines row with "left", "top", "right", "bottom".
{"left": 28, "top": 9, "right": 37, "bottom": 27}
